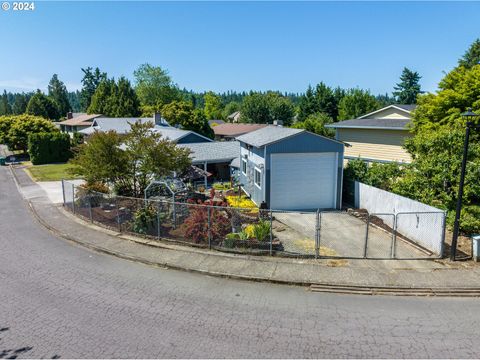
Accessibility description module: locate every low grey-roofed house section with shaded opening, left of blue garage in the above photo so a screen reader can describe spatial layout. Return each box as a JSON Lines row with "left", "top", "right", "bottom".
{"left": 178, "top": 141, "right": 240, "bottom": 187}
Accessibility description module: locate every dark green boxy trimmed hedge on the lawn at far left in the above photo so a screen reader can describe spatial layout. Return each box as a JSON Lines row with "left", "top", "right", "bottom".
{"left": 28, "top": 132, "right": 71, "bottom": 165}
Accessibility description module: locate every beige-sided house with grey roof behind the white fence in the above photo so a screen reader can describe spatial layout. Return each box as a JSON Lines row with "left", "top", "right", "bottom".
{"left": 326, "top": 104, "right": 415, "bottom": 163}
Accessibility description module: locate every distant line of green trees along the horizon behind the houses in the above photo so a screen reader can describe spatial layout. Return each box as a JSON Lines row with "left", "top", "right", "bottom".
{"left": 0, "top": 64, "right": 421, "bottom": 137}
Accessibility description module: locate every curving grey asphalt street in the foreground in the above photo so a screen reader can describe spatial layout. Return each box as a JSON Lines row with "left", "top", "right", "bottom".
{"left": 0, "top": 167, "right": 480, "bottom": 358}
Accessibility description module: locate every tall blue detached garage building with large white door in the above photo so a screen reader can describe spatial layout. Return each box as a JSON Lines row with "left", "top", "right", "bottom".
{"left": 237, "top": 126, "right": 344, "bottom": 210}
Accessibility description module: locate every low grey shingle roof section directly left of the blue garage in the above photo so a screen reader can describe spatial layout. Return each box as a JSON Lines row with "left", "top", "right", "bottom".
{"left": 177, "top": 141, "right": 240, "bottom": 163}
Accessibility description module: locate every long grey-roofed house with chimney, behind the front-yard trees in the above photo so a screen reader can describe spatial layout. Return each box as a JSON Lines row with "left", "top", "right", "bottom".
{"left": 80, "top": 113, "right": 212, "bottom": 144}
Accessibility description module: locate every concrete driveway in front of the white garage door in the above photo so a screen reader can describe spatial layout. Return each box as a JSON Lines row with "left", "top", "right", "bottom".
{"left": 274, "top": 212, "right": 427, "bottom": 259}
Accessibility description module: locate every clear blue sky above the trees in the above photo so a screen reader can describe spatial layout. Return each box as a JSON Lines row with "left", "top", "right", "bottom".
{"left": 0, "top": 1, "right": 480, "bottom": 93}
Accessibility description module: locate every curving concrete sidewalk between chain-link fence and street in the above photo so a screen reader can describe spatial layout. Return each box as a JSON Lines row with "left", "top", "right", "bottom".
{"left": 11, "top": 167, "right": 480, "bottom": 290}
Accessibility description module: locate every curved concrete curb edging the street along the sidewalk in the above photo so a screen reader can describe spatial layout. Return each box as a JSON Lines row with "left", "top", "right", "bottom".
{"left": 10, "top": 167, "right": 480, "bottom": 297}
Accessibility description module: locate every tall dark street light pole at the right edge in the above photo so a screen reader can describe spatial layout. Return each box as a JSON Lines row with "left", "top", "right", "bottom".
{"left": 450, "top": 108, "right": 478, "bottom": 261}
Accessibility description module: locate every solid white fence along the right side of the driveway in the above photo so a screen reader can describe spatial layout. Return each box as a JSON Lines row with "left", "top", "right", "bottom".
{"left": 354, "top": 181, "right": 446, "bottom": 255}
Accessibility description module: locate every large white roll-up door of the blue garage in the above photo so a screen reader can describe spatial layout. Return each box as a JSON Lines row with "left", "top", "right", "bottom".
{"left": 270, "top": 152, "right": 339, "bottom": 210}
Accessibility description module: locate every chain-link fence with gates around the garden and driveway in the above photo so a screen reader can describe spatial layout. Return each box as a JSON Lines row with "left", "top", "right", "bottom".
{"left": 62, "top": 181, "right": 445, "bottom": 259}
